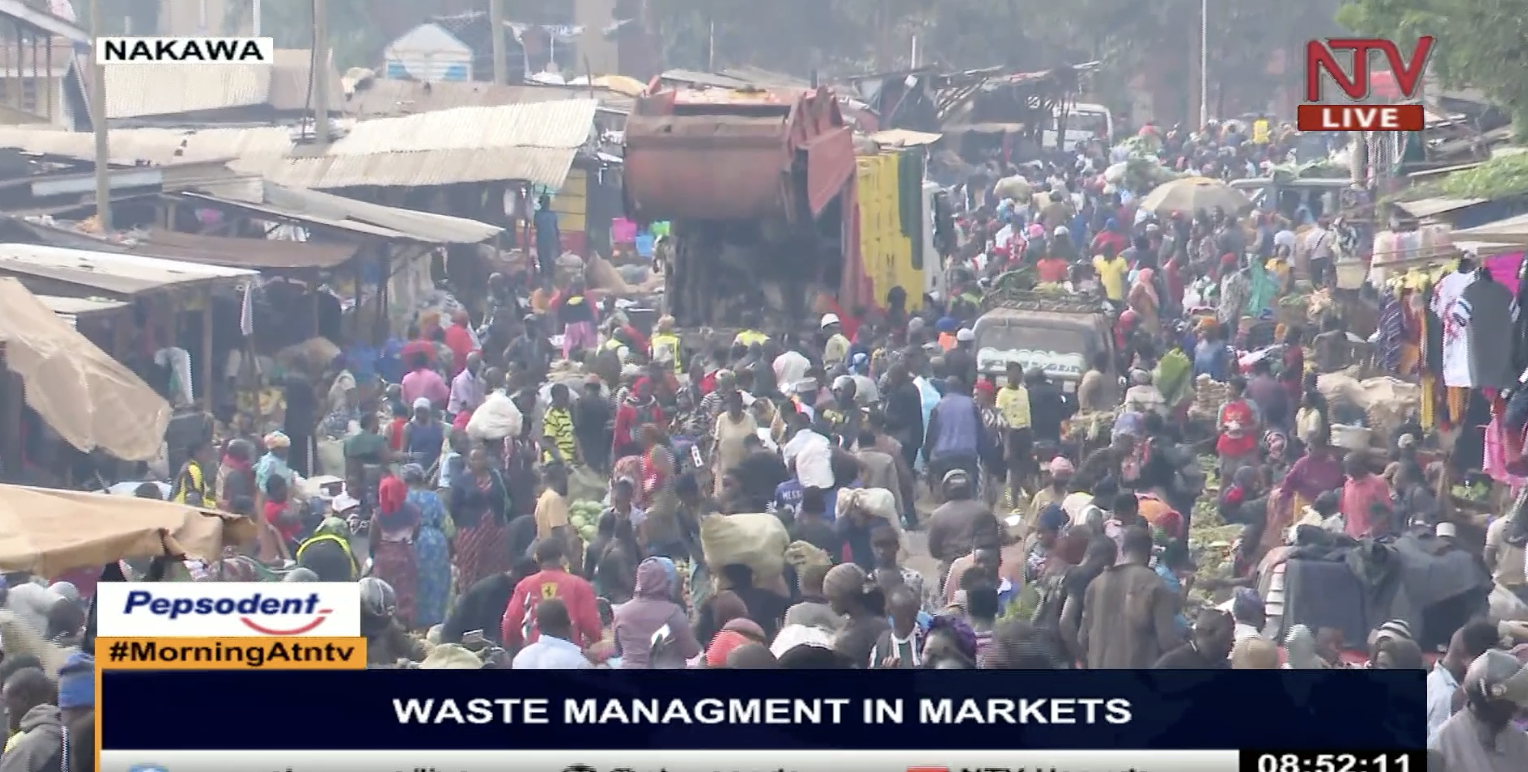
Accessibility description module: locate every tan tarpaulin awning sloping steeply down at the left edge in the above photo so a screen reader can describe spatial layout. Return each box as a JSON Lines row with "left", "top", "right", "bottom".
{"left": 0, "top": 278, "right": 171, "bottom": 462}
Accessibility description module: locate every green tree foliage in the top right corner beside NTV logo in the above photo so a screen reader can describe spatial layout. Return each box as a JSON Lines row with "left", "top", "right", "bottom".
{"left": 1337, "top": 0, "right": 1528, "bottom": 139}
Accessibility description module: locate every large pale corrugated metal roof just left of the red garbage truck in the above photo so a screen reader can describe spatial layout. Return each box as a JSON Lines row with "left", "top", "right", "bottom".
{"left": 262, "top": 99, "right": 599, "bottom": 190}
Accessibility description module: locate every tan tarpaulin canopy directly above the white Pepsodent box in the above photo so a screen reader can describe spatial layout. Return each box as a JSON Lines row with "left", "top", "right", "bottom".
{"left": 0, "top": 485, "right": 255, "bottom": 578}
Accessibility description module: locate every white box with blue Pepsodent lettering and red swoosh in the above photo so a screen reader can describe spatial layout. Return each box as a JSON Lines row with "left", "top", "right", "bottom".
{"left": 96, "top": 582, "right": 361, "bottom": 637}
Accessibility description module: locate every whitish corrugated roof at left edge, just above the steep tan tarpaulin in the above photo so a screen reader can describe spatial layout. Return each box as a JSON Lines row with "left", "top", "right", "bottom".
{"left": 0, "top": 243, "right": 258, "bottom": 297}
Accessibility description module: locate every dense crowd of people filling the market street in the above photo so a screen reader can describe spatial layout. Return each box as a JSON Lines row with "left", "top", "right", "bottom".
{"left": 0, "top": 121, "right": 1528, "bottom": 772}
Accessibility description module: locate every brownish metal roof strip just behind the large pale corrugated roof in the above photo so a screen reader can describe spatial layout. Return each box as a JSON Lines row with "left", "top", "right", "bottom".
{"left": 335, "top": 78, "right": 633, "bottom": 118}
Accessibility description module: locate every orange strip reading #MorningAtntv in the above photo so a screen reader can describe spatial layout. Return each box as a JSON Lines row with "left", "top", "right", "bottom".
{"left": 96, "top": 636, "right": 367, "bottom": 670}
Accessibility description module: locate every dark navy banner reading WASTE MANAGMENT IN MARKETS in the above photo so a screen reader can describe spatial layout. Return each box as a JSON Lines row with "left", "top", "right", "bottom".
{"left": 98, "top": 668, "right": 1427, "bottom": 746}
